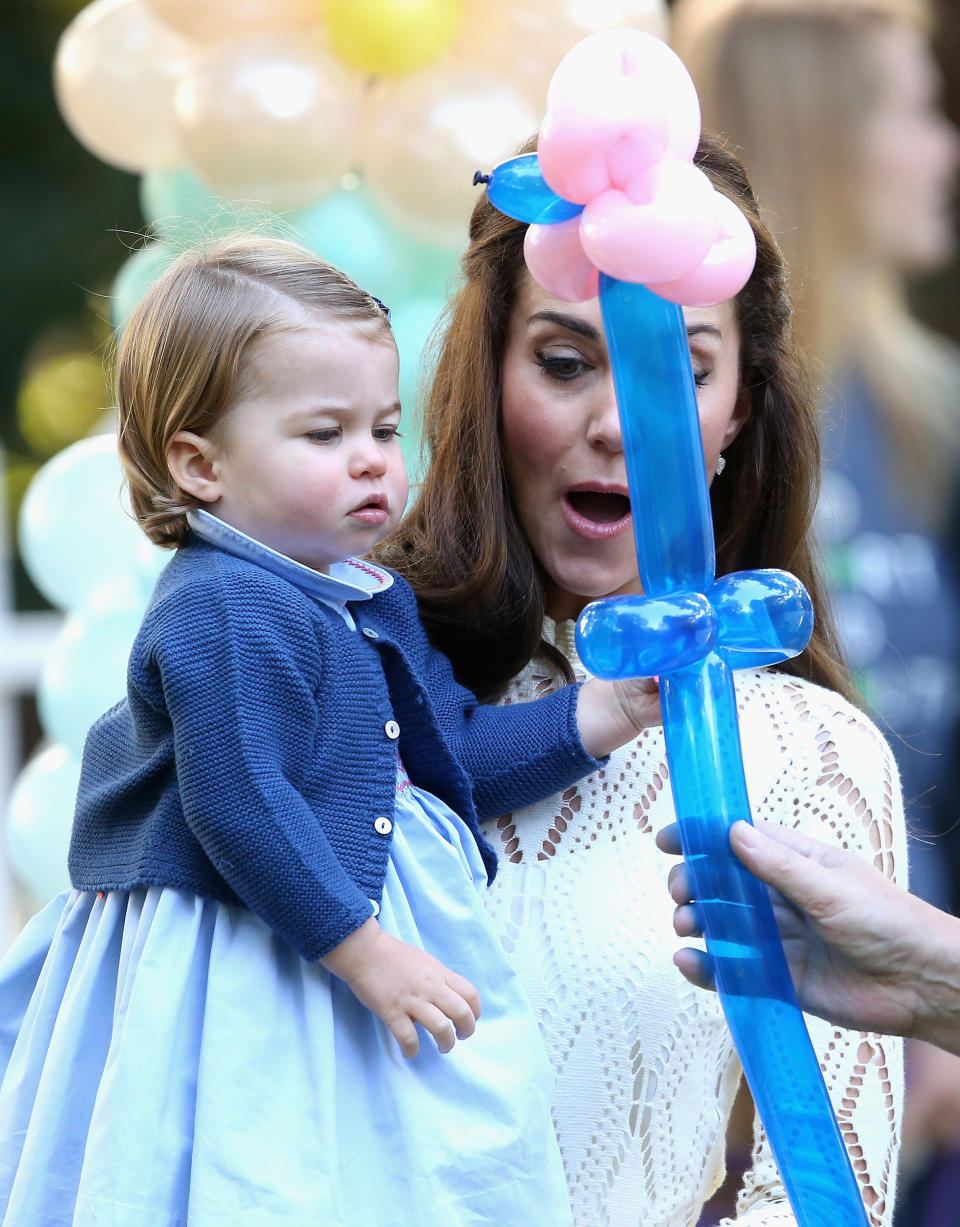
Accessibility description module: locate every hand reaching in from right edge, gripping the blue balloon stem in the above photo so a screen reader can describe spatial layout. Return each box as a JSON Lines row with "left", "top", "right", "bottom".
{"left": 657, "top": 822, "right": 960, "bottom": 1052}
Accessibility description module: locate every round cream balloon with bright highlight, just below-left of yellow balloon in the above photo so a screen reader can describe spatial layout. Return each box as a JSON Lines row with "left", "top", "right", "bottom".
{"left": 174, "top": 34, "right": 361, "bottom": 209}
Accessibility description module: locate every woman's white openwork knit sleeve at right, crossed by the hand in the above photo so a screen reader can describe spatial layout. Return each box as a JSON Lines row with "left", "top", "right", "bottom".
{"left": 724, "top": 687, "right": 907, "bottom": 1227}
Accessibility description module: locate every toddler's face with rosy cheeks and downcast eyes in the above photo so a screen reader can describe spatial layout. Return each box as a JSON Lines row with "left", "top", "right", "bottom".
{"left": 197, "top": 324, "right": 408, "bottom": 572}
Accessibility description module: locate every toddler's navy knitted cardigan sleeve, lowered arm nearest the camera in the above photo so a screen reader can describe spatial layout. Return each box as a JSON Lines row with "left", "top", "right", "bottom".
{"left": 151, "top": 568, "right": 372, "bottom": 960}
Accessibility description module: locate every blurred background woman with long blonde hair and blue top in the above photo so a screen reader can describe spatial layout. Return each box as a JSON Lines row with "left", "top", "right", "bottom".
{"left": 674, "top": 0, "right": 960, "bottom": 906}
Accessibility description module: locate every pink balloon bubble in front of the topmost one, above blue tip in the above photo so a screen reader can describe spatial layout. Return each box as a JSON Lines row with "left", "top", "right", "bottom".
{"left": 538, "top": 76, "right": 668, "bottom": 205}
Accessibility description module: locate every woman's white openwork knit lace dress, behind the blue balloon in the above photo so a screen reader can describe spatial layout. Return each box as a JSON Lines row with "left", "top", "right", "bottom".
{"left": 486, "top": 621, "right": 906, "bottom": 1227}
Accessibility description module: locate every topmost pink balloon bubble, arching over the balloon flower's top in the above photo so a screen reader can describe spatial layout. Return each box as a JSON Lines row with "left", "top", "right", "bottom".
{"left": 546, "top": 29, "right": 700, "bottom": 165}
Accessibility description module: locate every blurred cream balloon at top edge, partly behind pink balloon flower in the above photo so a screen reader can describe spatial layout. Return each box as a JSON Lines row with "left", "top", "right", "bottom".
{"left": 453, "top": 0, "right": 668, "bottom": 107}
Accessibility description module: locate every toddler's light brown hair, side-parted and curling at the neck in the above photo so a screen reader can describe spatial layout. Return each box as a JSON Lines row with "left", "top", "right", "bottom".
{"left": 115, "top": 236, "right": 392, "bottom": 548}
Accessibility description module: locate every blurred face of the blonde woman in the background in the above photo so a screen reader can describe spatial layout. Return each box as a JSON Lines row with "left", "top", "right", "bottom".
{"left": 858, "top": 26, "right": 960, "bottom": 272}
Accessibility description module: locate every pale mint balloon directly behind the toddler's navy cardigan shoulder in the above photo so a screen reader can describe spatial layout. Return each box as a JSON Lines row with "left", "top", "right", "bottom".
{"left": 37, "top": 577, "right": 147, "bottom": 757}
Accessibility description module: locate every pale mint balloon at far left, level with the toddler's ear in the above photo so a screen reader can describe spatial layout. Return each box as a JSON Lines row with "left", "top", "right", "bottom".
{"left": 18, "top": 434, "right": 142, "bottom": 609}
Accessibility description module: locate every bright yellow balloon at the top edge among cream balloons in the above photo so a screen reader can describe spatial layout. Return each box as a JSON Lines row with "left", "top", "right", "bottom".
{"left": 327, "top": 0, "right": 464, "bottom": 76}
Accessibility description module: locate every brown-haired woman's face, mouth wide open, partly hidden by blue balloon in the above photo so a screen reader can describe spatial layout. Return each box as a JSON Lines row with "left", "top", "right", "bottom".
{"left": 501, "top": 274, "right": 749, "bottom": 620}
